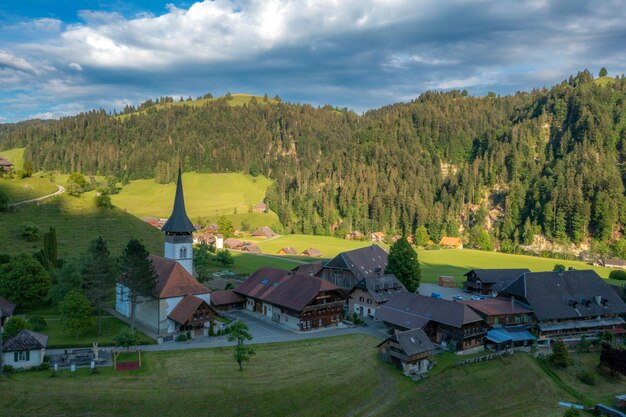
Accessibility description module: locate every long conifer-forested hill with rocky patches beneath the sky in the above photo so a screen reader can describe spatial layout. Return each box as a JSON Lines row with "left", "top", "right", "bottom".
{"left": 0, "top": 71, "right": 626, "bottom": 254}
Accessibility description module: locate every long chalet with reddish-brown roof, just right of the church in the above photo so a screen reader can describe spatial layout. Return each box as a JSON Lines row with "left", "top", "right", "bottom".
{"left": 234, "top": 267, "right": 347, "bottom": 330}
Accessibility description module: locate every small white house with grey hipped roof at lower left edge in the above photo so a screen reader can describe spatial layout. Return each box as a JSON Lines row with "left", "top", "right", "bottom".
{"left": 2, "top": 330, "right": 48, "bottom": 369}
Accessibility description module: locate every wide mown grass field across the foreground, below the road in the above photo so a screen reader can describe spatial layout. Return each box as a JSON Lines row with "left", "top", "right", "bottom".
{"left": 0, "top": 335, "right": 608, "bottom": 417}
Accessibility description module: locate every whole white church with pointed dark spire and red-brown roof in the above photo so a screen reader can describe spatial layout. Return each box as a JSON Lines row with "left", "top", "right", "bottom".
{"left": 115, "top": 168, "right": 216, "bottom": 336}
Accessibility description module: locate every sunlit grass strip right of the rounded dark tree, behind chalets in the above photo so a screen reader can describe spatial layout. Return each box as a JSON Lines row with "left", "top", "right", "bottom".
{"left": 418, "top": 249, "right": 624, "bottom": 285}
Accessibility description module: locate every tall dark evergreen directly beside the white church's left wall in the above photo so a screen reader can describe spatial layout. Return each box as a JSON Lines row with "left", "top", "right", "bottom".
{"left": 119, "top": 239, "right": 157, "bottom": 331}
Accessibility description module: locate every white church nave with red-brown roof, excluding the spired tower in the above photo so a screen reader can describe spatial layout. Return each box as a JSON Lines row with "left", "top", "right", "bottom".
{"left": 115, "top": 255, "right": 214, "bottom": 334}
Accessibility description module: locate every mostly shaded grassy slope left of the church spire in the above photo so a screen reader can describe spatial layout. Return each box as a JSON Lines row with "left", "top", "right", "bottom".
{"left": 0, "top": 192, "right": 163, "bottom": 258}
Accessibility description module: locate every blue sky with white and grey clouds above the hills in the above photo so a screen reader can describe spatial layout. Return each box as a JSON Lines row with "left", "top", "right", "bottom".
{"left": 0, "top": 0, "right": 626, "bottom": 123}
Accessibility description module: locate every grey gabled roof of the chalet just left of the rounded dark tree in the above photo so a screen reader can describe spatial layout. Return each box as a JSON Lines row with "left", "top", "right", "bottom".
{"left": 324, "top": 245, "right": 388, "bottom": 279}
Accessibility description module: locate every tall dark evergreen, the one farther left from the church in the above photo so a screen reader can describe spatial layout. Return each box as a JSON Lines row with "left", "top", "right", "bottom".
{"left": 81, "top": 236, "right": 115, "bottom": 336}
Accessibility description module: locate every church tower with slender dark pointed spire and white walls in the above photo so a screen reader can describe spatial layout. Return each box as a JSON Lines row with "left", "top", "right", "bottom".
{"left": 161, "top": 166, "right": 196, "bottom": 275}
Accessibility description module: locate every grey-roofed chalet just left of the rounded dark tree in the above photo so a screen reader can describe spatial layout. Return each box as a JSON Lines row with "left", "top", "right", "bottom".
{"left": 317, "top": 245, "right": 388, "bottom": 291}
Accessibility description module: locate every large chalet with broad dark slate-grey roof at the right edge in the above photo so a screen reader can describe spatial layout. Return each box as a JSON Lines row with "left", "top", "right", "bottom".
{"left": 498, "top": 270, "right": 626, "bottom": 345}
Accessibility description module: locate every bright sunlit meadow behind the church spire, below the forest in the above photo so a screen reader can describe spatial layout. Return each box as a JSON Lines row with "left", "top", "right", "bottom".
{"left": 111, "top": 172, "right": 279, "bottom": 227}
